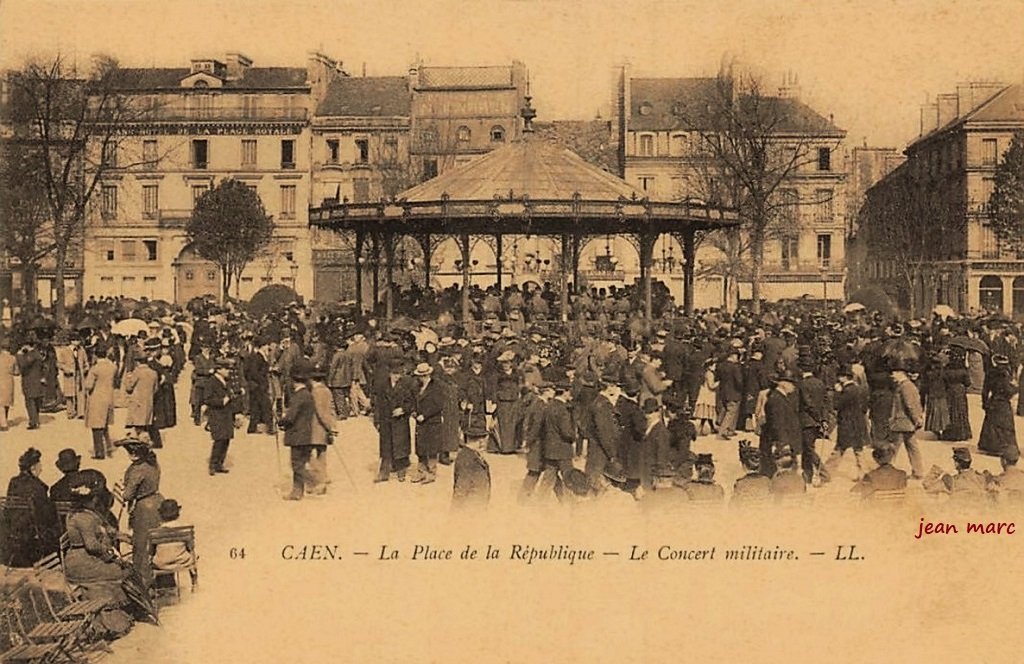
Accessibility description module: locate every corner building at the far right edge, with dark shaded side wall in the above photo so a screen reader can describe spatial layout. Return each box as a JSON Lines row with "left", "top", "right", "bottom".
{"left": 856, "top": 83, "right": 1024, "bottom": 316}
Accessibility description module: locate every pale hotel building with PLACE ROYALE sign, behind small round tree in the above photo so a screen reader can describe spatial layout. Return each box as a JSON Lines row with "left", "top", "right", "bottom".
{"left": 84, "top": 53, "right": 344, "bottom": 302}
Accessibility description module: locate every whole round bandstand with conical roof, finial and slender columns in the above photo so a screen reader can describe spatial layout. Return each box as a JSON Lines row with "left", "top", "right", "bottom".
{"left": 309, "top": 101, "right": 738, "bottom": 320}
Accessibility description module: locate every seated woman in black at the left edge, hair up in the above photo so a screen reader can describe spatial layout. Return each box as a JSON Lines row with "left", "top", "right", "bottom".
{"left": 0, "top": 448, "right": 60, "bottom": 568}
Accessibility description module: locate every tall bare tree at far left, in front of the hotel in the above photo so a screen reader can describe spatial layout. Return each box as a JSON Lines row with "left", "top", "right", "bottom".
{"left": 9, "top": 54, "right": 159, "bottom": 322}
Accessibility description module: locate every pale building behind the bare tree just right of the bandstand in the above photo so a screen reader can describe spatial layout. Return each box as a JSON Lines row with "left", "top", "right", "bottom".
{"left": 611, "top": 71, "right": 846, "bottom": 307}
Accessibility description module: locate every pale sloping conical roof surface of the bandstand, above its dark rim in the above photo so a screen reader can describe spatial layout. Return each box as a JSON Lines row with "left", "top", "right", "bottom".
{"left": 397, "top": 134, "right": 645, "bottom": 203}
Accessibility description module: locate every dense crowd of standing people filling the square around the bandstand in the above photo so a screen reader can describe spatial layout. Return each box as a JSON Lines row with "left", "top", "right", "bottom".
{"left": 0, "top": 286, "right": 1024, "bottom": 518}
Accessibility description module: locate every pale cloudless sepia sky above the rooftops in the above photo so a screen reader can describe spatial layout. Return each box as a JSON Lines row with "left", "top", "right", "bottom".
{"left": 0, "top": 0, "right": 1024, "bottom": 147}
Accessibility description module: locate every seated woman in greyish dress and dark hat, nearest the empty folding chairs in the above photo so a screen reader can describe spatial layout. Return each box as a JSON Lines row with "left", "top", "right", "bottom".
{"left": 65, "top": 478, "right": 156, "bottom": 637}
